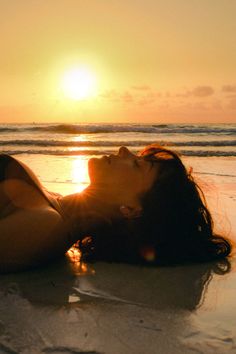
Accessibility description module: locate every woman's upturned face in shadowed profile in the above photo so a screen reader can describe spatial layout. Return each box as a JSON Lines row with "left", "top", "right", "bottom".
{"left": 88, "top": 147, "right": 158, "bottom": 204}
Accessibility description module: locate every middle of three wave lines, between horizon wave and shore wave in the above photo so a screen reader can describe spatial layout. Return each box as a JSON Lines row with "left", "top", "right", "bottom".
{"left": 0, "top": 139, "right": 236, "bottom": 147}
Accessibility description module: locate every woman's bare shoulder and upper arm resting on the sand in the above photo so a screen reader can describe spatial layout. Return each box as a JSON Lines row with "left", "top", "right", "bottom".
{"left": 0, "top": 201, "right": 71, "bottom": 273}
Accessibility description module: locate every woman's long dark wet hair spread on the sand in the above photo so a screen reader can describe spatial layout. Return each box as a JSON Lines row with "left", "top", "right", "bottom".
{"left": 78, "top": 145, "right": 231, "bottom": 265}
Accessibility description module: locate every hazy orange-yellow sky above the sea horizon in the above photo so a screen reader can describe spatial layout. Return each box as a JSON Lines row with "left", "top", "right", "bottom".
{"left": 0, "top": 0, "right": 236, "bottom": 123}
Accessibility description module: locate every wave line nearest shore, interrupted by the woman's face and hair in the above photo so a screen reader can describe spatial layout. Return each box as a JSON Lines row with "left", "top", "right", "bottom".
{"left": 2, "top": 149, "right": 236, "bottom": 157}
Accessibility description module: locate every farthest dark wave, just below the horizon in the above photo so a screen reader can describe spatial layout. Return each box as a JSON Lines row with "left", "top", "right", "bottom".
{"left": 0, "top": 124, "right": 236, "bottom": 136}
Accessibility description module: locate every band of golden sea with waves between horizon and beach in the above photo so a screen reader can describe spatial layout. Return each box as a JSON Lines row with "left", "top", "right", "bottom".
{"left": 0, "top": 124, "right": 236, "bottom": 156}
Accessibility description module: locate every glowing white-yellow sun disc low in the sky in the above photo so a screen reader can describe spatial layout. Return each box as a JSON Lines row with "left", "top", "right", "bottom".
{"left": 61, "top": 67, "right": 97, "bottom": 101}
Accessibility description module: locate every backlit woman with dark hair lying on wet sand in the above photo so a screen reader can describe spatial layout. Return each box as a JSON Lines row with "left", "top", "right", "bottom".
{"left": 0, "top": 145, "right": 231, "bottom": 271}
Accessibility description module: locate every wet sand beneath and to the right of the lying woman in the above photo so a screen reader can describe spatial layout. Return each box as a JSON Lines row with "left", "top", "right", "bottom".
{"left": 0, "top": 158, "right": 236, "bottom": 354}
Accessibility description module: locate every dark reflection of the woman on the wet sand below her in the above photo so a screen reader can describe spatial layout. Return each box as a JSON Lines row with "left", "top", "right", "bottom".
{"left": 0, "top": 254, "right": 230, "bottom": 310}
